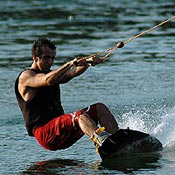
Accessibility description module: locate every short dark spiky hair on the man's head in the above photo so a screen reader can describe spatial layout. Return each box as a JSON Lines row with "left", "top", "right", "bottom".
{"left": 32, "top": 38, "right": 56, "bottom": 57}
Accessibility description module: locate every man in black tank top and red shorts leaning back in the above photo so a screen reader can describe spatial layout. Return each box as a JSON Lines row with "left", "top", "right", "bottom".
{"left": 15, "top": 39, "right": 118, "bottom": 150}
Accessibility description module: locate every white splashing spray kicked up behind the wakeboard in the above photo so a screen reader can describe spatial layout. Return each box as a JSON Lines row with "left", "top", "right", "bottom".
{"left": 119, "top": 107, "right": 175, "bottom": 150}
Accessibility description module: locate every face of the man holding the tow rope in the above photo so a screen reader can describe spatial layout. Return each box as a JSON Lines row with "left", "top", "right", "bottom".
{"left": 37, "top": 47, "right": 56, "bottom": 72}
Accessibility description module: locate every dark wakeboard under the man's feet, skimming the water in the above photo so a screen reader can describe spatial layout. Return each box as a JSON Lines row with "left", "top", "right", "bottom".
{"left": 98, "top": 129, "right": 163, "bottom": 161}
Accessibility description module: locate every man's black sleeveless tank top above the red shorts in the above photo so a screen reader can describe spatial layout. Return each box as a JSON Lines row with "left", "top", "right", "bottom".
{"left": 15, "top": 69, "right": 64, "bottom": 136}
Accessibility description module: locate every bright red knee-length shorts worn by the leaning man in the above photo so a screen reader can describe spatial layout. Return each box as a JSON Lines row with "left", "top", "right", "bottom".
{"left": 34, "top": 104, "right": 98, "bottom": 151}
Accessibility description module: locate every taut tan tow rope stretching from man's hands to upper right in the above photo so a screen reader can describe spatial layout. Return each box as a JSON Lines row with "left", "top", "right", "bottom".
{"left": 80, "top": 16, "right": 175, "bottom": 61}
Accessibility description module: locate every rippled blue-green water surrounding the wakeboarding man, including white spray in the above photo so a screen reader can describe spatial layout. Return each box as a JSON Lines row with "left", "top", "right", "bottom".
{"left": 0, "top": 0, "right": 175, "bottom": 175}
